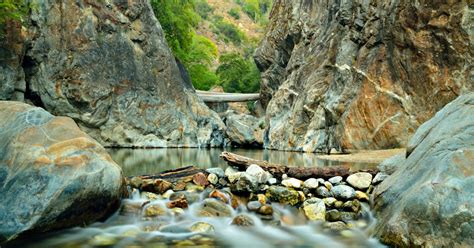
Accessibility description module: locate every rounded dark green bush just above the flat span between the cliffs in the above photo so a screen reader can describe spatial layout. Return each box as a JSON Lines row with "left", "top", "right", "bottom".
{"left": 216, "top": 53, "right": 260, "bottom": 93}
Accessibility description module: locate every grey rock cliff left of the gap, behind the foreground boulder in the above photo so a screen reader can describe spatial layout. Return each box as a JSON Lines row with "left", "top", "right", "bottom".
{"left": 0, "top": 0, "right": 224, "bottom": 147}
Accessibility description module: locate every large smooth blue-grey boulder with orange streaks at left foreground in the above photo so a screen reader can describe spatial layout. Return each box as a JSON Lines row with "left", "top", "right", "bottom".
{"left": 0, "top": 101, "right": 124, "bottom": 242}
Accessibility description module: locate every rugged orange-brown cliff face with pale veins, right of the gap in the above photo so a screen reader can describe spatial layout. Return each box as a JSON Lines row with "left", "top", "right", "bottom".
{"left": 255, "top": 0, "right": 474, "bottom": 152}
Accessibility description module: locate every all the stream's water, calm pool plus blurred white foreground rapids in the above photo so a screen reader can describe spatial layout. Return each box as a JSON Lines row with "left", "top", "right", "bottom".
{"left": 8, "top": 149, "right": 382, "bottom": 248}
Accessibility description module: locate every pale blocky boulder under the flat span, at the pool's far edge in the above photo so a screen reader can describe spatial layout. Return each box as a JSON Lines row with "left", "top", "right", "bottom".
{"left": 224, "top": 114, "right": 263, "bottom": 147}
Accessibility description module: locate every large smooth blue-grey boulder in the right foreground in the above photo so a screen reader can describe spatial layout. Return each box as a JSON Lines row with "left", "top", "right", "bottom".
{"left": 375, "top": 93, "right": 474, "bottom": 247}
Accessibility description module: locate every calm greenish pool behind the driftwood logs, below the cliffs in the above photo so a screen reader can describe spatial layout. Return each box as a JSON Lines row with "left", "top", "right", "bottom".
{"left": 108, "top": 148, "right": 376, "bottom": 176}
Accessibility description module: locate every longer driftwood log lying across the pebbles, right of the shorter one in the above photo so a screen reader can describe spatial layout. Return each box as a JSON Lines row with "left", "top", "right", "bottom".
{"left": 220, "top": 152, "right": 378, "bottom": 180}
